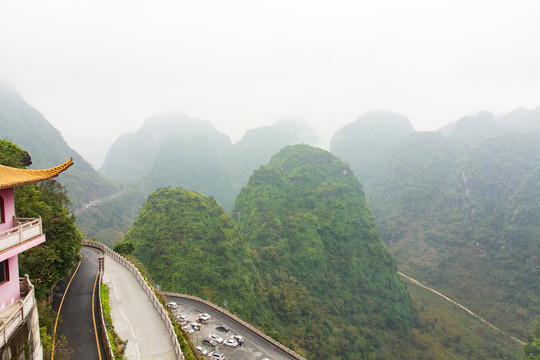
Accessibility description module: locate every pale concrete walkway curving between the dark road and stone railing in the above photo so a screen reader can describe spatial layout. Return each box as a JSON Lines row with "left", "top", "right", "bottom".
{"left": 103, "top": 255, "right": 176, "bottom": 360}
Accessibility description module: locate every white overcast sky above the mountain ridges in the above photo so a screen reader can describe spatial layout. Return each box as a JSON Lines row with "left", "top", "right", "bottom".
{"left": 0, "top": 0, "right": 540, "bottom": 168}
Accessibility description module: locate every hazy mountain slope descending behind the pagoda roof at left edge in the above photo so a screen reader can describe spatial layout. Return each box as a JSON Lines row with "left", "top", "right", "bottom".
{"left": 0, "top": 86, "right": 116, "bottom": 207}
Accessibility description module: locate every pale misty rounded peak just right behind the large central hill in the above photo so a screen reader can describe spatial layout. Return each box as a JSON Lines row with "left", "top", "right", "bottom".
{"left": 330, "top": 111, "right": 415, "bottom": 187}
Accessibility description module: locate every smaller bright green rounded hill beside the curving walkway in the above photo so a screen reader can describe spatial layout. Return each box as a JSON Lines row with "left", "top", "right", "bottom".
{"left": 116, "top": 188, "right": 261, "bottom": 318}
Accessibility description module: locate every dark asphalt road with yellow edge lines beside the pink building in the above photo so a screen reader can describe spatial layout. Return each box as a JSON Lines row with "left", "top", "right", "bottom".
{"left": 53, "top": 248, "right": 105, "bottom": 360}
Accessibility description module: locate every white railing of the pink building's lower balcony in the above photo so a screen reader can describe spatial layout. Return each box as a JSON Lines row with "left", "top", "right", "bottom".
{"left": 0, "top": 275, "right": 36, "bottom": 348}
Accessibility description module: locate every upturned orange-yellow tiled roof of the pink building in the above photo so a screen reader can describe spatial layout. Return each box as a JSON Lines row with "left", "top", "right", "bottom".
{"left": 0, "top": 158, "right": 73, "bottom": 189}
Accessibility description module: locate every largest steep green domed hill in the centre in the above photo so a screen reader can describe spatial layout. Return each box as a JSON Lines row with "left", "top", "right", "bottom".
{"left": 233, "top": 145, "right": 412, "bottom": 359}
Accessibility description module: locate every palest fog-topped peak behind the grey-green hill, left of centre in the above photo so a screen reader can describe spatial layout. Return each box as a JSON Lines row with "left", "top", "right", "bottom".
{"left": 100, "top": 113, "right": 231, "bottom": 182}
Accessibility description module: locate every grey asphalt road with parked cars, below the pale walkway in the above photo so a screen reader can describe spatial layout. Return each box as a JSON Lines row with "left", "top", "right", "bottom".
{"left": 167, "top": 296, "right": 294, "bottom": 360}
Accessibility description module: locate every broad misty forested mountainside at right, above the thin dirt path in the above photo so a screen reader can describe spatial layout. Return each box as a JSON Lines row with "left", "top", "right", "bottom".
{"left": 332, "top": 109, "right": 540, "bottom": 358}
